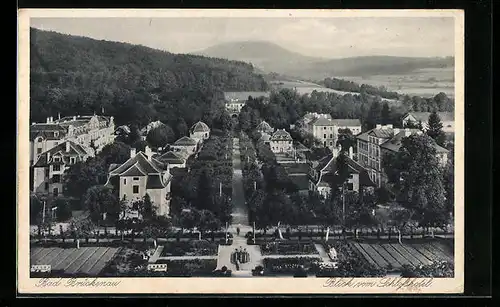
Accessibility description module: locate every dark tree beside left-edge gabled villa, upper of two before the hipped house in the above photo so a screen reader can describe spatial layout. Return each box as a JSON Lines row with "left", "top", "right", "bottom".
{"left": 63, "top": 157, "right": 107, "bottom": 198}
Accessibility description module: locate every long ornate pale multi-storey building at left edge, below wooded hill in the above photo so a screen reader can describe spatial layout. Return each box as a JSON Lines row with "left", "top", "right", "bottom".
{"left": 30, "top": 115, "right": 115, "bottom": 165}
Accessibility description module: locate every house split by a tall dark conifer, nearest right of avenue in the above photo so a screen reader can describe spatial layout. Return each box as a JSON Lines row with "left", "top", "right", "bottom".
{"left": 309, "top": 151, "right": 375, "bottom": 198}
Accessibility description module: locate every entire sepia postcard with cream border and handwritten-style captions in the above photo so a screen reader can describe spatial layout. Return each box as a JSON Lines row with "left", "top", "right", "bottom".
{"left": 17, "top": 10, "right": 464, "bottom": 293}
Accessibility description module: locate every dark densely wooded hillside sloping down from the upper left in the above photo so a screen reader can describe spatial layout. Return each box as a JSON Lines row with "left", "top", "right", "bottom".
{"left": 30, "top": 28, "right": 267, "bottom": 129}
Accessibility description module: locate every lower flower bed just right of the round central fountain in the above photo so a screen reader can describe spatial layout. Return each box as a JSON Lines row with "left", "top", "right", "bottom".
{"left": 264, "top": 257, "right": 321, "bottom": 274}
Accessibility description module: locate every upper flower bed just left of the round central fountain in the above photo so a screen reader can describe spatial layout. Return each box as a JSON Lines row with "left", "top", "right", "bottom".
{"left": 160, "top": 240, "right": 218, "bottom": 257}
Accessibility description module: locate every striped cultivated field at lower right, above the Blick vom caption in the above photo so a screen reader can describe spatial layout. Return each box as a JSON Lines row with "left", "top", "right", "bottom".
{"left": 350, "top": 240, "right": 453, "bottom": 270}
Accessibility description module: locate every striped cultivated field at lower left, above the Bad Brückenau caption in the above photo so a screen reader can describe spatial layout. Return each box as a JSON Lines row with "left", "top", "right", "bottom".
{"left": 30, "top": 247, "right": 120, "bottom": 276}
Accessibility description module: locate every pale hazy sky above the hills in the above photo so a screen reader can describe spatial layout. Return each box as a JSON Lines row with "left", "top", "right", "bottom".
{"left": 31, "top": 17, "right": 454, "bottom": 58}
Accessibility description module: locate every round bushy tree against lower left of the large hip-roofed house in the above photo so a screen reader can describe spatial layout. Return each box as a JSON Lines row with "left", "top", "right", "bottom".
{"left": 82, "top": 186, "right": 118, "bottom": 222}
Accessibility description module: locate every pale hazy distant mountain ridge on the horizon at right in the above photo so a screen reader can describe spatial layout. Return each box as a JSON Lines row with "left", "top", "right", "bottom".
{"left": 193, "top": 41, "right": 454, "bottom": 80}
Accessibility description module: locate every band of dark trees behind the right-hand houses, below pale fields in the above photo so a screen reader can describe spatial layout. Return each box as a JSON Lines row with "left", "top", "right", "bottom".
{"left": 239, "top": 89, "right": 453, "bottom": 132}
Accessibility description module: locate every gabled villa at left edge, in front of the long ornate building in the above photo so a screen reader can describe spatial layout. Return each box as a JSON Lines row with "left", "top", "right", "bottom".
{"left": 31, "top": 140, "right": 91, "bottom": 197}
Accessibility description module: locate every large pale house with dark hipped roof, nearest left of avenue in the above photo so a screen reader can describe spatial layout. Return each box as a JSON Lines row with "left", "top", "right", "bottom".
{"left": 106, "top": 146, "right": 172, "bottom": 215}
